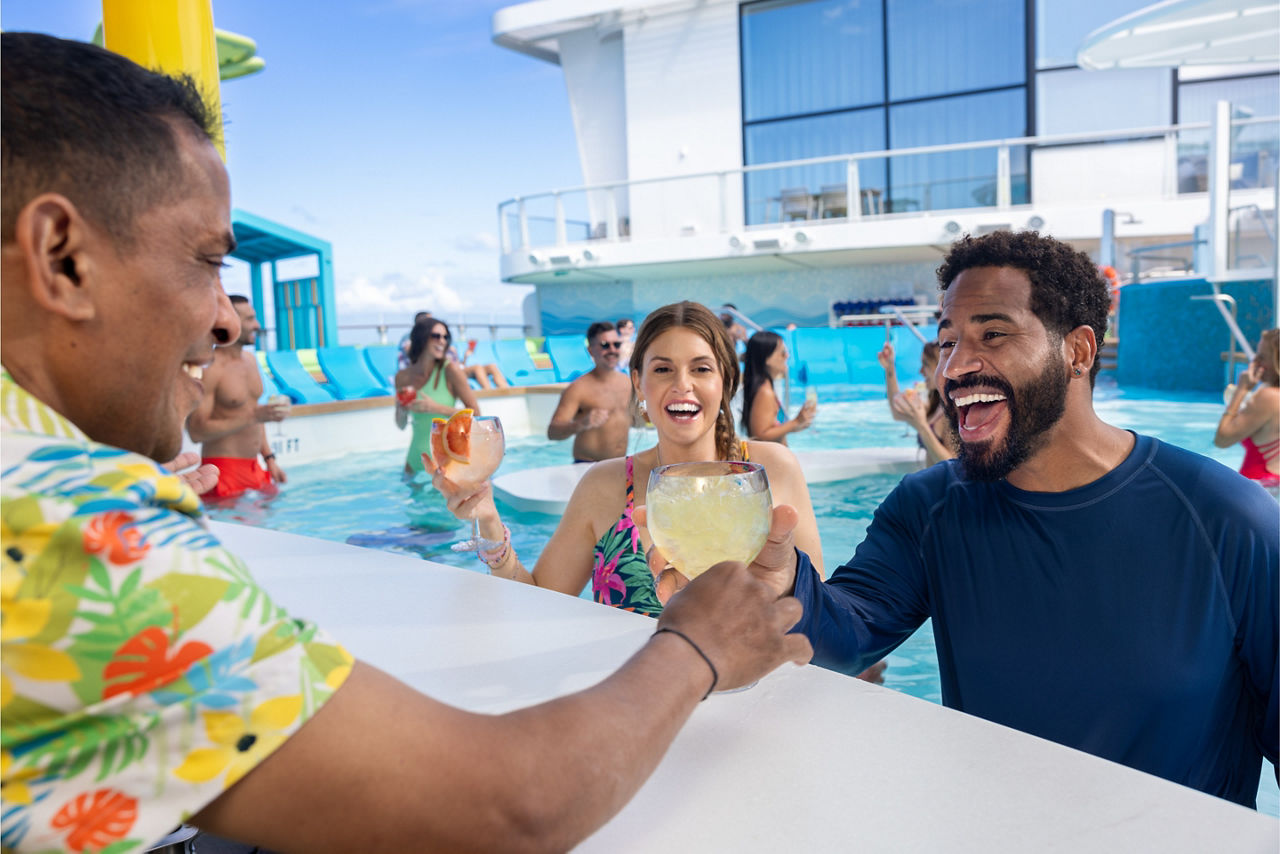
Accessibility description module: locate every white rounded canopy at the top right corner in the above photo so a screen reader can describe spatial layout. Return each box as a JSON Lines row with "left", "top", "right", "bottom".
{"left": 1076, "top": 0, "right": 1280, "bottom": 70}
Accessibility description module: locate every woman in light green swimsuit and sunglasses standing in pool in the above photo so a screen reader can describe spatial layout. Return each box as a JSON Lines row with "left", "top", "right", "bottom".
{"left": 396, "top": 318, "right": 480, "bottom": 474}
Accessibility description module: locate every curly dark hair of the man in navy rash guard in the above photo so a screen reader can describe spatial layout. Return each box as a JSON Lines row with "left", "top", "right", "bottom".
{"left": 938, "top": 230, "right": 1111, "bottom": 385}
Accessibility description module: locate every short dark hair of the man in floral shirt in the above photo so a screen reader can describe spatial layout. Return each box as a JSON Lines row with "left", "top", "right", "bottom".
{"left": 0, "top": 32, "right": 218, "bottom": 247}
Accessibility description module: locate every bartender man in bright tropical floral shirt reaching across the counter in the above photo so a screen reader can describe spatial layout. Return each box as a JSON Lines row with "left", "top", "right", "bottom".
{"left": 0, "top": 33, "right": 810, "bottom": 854}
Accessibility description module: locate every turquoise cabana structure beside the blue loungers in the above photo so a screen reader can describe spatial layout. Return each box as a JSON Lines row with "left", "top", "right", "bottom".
{"left": 232, "top": 210, "right": 338, "bottom": 350}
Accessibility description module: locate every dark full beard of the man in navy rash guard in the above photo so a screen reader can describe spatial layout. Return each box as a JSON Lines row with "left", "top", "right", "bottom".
{"left": 942, "top": 352, "right": 1068, "bottom": 481}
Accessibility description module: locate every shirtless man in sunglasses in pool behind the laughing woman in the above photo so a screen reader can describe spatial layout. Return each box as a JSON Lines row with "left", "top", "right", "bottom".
{"left": 547, "top": 320, "right": 631, "bottom": 462}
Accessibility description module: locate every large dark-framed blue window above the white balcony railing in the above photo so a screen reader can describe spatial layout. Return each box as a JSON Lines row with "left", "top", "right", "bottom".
{"left": 741, "top": 0, "right": 1029, "bottom": 224}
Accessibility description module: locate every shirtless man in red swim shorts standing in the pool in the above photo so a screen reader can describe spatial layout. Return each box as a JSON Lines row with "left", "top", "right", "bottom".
{"left": 187, "top": 294, "right": 289, "bottom": 501}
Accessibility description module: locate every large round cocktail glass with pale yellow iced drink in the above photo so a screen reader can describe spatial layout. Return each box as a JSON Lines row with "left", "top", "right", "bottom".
{"left": 645, "top": 461, "right": 773, "bottom": 693}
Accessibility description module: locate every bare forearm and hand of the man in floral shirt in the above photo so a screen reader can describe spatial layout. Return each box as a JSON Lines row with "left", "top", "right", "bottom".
{"left": 192, "top": 563, "right": 812, "bottom": 851}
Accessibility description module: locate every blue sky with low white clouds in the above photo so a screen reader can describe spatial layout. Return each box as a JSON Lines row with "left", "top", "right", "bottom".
{"left": 0, "top": 0, "right": 581, "bottom": 343}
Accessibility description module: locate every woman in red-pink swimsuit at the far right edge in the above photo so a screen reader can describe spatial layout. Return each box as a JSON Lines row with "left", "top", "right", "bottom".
{"left": 1213, "top": 329, "right": 1280, "bottom": 489}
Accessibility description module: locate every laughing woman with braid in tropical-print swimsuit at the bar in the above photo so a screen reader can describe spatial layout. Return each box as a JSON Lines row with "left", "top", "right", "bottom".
{"left": 434, "top": 302, "right": 822, "bottom": 617}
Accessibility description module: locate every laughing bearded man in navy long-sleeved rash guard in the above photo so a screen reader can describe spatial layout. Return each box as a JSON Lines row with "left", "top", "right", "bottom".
{"left": 754, "top": 232, "right": 1280, "bottom": 807}
